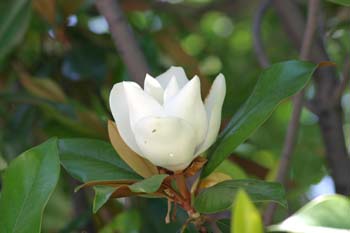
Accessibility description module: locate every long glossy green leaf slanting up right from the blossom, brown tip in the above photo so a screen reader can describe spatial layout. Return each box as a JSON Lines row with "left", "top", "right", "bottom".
{"left": 202, "top": 61, "right": 317, "bottom": 177}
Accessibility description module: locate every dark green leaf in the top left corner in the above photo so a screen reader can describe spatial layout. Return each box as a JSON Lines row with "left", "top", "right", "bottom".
{"left": 0, "top": 0, "right": 32, "bottom": 62}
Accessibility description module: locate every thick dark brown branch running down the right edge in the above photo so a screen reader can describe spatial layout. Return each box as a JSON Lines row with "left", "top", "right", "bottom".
{"left": 274, "top": 0, "right": 350, "bottom": 195}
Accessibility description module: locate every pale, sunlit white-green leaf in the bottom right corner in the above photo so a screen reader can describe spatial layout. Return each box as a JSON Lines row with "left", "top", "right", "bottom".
{"left": 268, "top": 195, "right": 350, "bottom": 233}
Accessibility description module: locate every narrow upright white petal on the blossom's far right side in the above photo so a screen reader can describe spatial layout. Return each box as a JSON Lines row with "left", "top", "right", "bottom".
{"left": 196, "top": 74, "right": 226, "bottom": 155}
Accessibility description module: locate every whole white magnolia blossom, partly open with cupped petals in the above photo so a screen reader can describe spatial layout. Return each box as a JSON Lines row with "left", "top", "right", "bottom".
{"left": 109, "top": 67, "right": 226, "bottom": 171}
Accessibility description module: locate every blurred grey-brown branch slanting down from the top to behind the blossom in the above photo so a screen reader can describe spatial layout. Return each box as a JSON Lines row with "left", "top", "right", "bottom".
{"left": 96, "top": 0, "right": 149, "bottom": 84}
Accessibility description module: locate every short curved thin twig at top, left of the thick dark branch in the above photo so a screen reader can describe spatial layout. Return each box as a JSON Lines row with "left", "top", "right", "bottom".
{"left": 253, "top": 0, "right": 271, "bottom": 68}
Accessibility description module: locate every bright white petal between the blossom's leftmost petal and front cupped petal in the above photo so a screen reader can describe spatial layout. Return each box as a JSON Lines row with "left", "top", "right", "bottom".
{"left": 123, "top": 82, "right": 163, "bottom": 130}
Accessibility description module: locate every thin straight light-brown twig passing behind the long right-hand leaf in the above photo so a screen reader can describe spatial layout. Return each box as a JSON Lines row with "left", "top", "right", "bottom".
{"left": 264, "top": 0, "right": 320, "bottom": 225}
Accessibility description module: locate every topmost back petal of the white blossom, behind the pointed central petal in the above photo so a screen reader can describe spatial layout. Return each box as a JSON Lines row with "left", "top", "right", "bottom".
{"left": 156, "top": 66, "right": 188, "bottom": 89}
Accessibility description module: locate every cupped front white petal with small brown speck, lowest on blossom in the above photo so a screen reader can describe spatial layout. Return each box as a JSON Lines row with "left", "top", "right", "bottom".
{"left": 135, "top": 117, "right": 195, "bottom": 171}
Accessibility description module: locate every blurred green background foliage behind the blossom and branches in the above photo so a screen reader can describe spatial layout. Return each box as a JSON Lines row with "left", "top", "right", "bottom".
{"left": 0, "top": 0, "right": 350, "bottom": 233}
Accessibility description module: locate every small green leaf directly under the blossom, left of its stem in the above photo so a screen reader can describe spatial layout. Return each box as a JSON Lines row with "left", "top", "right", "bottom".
{"left": 129, "top": 174, "right": 168, "bottom": 193}
